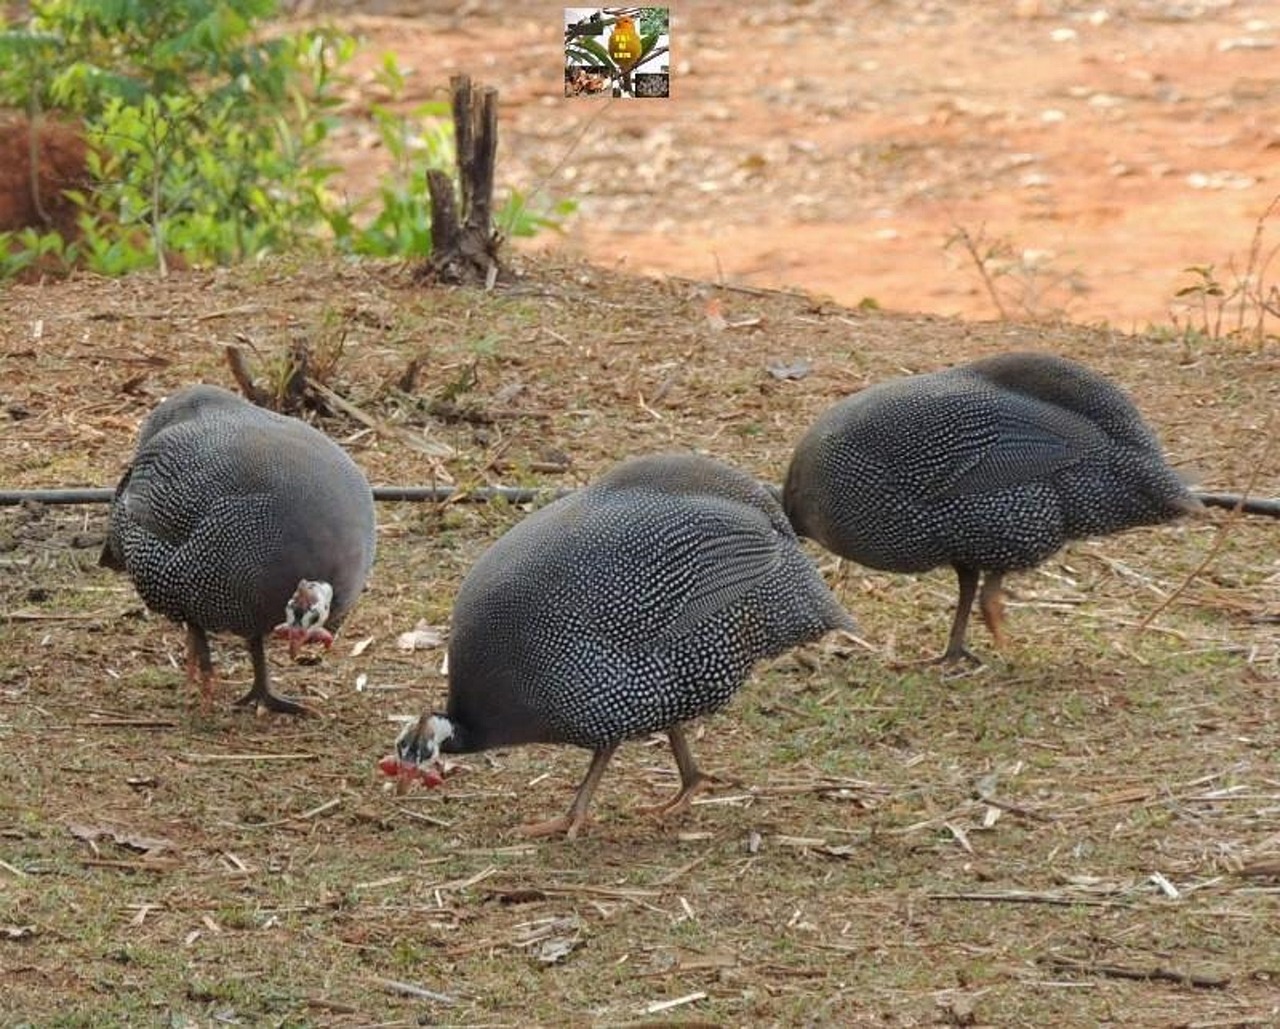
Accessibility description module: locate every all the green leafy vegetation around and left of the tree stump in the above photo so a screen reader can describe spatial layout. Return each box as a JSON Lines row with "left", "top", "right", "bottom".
{"left": 0, "top": 0, "right": 575, "bottom": 278}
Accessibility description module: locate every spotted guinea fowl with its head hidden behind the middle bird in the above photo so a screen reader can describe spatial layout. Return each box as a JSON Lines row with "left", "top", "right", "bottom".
{"left": 783, "top": 353, "right": 1201, "bottom": 660}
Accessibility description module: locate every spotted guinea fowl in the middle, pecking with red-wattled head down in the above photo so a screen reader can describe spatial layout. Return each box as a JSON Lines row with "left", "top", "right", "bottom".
{"left": 383, "top": 454, "right": 852, "bottom": 837}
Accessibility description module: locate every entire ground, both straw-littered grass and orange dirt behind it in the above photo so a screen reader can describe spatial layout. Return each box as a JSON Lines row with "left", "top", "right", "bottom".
{"left": 0, "top": 0, "right": 1280, "bottom": 1029}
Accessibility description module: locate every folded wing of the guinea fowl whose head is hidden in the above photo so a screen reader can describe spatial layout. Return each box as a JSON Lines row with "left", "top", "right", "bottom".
{"left": 932, "top": 394, "right": 1107, "bottom": 499}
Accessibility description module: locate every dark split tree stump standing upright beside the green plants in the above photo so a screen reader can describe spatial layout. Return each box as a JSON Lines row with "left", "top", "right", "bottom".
{"left": 415, "top": 76, "right": 503, "bottom": 288}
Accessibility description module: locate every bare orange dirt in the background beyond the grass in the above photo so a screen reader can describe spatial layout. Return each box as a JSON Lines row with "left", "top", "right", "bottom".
{"left": 314, "top": 0, "right": 1280, "bottom": 331}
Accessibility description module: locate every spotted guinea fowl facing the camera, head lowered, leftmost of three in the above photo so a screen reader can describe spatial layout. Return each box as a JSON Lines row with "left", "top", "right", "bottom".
{"left": 101, "top": 385, "right": 374, "bottom": 714}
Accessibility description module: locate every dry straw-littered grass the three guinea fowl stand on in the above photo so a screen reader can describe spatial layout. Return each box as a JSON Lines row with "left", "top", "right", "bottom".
{"left": 0, "top": 250, "right": 1280, "bottom": 1026}
